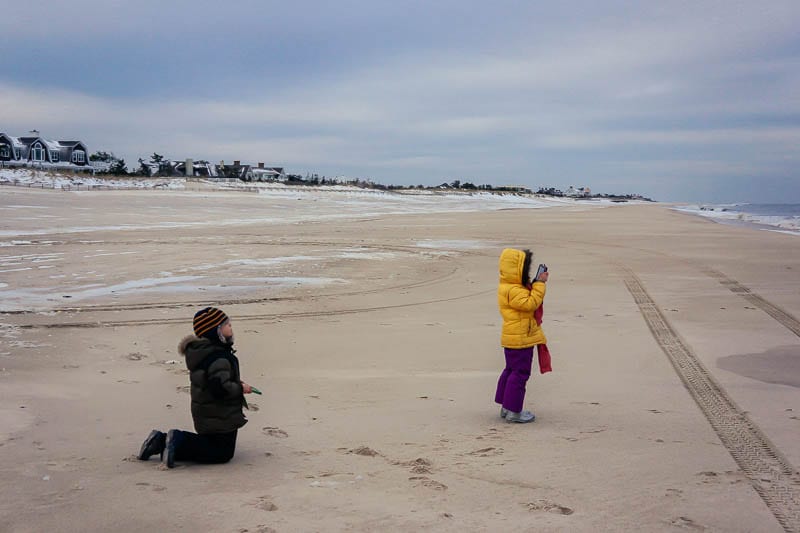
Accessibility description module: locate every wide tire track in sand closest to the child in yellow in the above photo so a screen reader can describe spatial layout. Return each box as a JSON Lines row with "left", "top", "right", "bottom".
{"left": 623, "top": 268, "right": 800, "bottom": 532}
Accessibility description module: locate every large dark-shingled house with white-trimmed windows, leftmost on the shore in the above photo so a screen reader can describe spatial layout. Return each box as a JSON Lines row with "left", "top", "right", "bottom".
{"left": 0, "top": 130, "right": 94, "bottom": 172}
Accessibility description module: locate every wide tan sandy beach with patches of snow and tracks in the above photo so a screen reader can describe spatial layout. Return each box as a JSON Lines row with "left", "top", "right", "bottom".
{"left": 0, "top": 187, "right": 800, "bottom": 532}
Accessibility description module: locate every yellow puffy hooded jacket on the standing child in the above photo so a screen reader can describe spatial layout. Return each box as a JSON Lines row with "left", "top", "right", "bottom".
{"left": 497, "top": 248, "right": 547, "bottom": 348}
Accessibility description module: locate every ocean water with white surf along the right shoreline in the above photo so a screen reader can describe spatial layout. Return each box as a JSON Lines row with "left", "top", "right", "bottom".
{"left": 675, "top": 203, "right": 800, "bottom": 236}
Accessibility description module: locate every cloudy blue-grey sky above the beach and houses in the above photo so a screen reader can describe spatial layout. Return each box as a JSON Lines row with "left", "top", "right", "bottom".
{"left": 0, "top": 0, "right": 800, "bottom": 203}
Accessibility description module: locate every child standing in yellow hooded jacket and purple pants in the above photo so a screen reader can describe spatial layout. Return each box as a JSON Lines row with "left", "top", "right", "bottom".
{"left": 494, "top": 248, "right": 548, "bottom": 422}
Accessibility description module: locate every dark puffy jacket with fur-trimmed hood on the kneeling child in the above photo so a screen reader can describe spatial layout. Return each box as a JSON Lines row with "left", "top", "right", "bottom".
{"left": 178, "top": 335, "right": 247, "bottom": 434}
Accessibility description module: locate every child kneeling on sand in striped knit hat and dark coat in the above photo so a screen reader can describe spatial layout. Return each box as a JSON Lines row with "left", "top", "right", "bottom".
{"left": 138, "top": 307, "right": 252, "bottom": 468}
